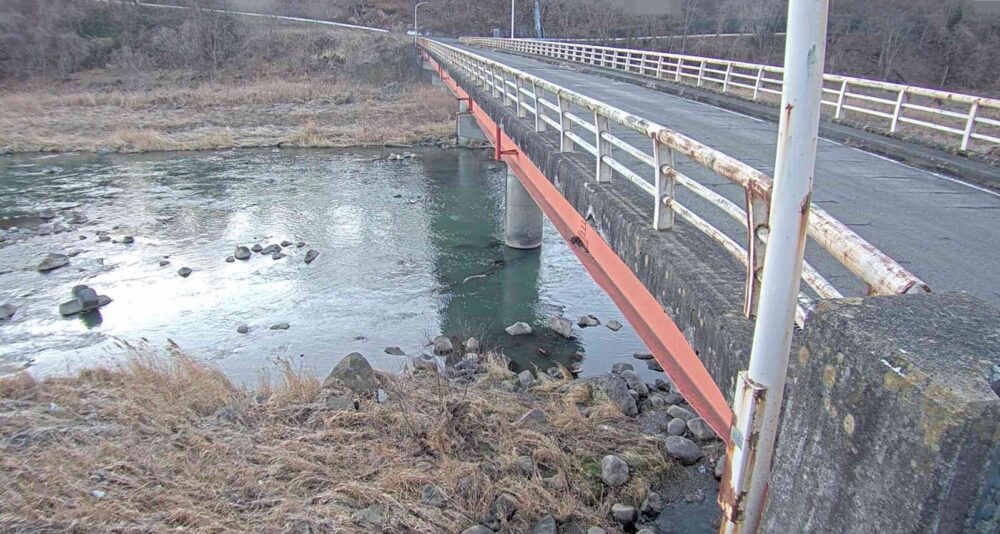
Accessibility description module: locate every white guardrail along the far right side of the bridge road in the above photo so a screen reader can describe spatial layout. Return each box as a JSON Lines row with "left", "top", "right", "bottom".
{"left": 462, "top": 37, "right": 1000, "bottom": 152}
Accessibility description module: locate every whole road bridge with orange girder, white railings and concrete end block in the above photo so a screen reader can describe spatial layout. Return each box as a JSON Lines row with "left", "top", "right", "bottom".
{"left": 417, "top": 30, "right": 1000, "bottom": 532}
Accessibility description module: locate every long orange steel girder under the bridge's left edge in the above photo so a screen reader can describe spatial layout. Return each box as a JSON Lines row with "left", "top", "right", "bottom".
{"left": 420, "top": 49, "right": 733, "bottom": 444}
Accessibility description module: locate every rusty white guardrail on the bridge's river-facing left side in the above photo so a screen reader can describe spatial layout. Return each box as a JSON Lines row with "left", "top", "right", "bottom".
{"left": 417, "top": 38, "right": 929, "bottom": 325}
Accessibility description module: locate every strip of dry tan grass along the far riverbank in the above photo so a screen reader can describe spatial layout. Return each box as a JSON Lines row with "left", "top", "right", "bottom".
{"left": 0, "top": 77, "right": 454, "bottom": 152}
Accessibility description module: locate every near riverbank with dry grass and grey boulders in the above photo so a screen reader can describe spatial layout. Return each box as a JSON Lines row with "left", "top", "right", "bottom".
{"left": 0, "top": 340, "right": 722, "bottom": 534}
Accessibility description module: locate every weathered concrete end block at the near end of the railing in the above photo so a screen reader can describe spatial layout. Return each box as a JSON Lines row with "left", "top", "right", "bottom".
{"left": 765, "top": 293, "right": 1000, "bottom": 533}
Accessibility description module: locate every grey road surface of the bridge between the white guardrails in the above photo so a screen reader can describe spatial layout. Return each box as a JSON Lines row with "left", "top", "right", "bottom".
{"left": 448, "top": 41, "right": 1000, "bottom": 303}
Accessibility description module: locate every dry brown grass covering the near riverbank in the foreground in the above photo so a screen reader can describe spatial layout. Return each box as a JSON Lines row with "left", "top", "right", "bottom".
{"left": 0, "top": 349, "right": 667, "bottom": 533}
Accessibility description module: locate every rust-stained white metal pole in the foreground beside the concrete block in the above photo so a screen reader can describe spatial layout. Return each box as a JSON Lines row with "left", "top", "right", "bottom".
{"left": 722, "top": 0, "right": 829, "bottom": 533}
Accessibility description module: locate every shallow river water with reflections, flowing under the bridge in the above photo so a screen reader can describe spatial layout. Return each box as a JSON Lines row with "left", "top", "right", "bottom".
{"left": 0, "top": 149, "right": 656, "bottom": 384}
